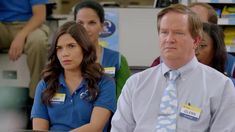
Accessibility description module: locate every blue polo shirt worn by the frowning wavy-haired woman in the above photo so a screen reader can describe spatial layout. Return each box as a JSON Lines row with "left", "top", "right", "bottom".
{"left": 31, "top": 74, "right": 116, "bottom": 132}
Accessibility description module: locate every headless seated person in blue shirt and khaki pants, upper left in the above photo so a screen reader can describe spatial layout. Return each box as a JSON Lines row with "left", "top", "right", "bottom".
{"left": 0, "top": 0, "right": 49, "bottom": 99}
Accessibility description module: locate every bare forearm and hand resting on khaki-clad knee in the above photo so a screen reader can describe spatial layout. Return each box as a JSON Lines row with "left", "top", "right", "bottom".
{"left": 8, "top": 5, "right": 46, "bottom": 61}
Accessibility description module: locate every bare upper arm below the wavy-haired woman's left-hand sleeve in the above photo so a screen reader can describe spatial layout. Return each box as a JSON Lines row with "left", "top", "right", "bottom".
{"left": 33, "top": 118, "right": 49, "bottom": 131}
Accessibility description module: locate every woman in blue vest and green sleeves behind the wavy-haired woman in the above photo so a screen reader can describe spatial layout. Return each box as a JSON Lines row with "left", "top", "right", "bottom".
{"left": 74, "top": 0, "right": 131, "bottom": 97}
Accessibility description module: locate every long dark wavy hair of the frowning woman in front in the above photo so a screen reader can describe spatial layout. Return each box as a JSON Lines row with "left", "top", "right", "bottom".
{"left": 42, "top": 21, "right": 104, "bottom": 105}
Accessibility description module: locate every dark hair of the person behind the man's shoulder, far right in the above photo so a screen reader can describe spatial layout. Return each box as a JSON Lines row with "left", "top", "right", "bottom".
{"left": 203, "top": 23, "right": 227, "bottom": 73}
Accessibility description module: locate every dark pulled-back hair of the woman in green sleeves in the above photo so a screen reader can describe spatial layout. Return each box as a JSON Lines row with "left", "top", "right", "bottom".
{"left": 74, "top": 0, "right": 105, "bottom": 23}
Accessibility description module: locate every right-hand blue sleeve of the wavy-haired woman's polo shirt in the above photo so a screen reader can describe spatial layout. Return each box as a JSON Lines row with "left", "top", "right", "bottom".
{"left": 94, "top": 76, "right": 116, "bottom": 113}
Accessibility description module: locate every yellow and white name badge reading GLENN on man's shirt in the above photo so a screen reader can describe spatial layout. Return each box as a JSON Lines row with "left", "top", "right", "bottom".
{"left": 180, "top": 104, "right": 202, "bottom": 121}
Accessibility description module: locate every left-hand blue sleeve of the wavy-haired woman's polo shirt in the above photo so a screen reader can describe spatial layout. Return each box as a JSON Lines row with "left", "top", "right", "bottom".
{"left": 31, "top": 80, "right": 49, "bottom": 121}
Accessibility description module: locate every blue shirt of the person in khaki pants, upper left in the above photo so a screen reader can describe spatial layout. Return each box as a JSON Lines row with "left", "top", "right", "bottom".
{"left": 0, "top": 0, "right": 48, "bottom": 22}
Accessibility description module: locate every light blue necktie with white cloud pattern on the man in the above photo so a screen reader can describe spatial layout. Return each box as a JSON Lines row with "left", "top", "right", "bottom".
{"left": 156, "top": 70, "right": 180, "bottom": 132}
